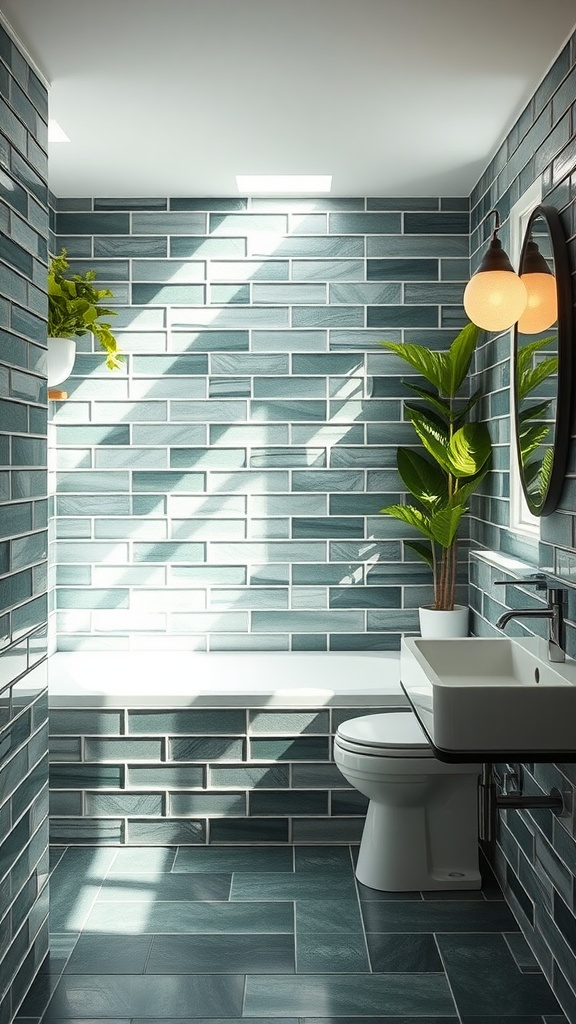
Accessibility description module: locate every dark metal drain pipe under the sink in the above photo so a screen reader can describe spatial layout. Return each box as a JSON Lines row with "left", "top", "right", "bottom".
{"left": 478, "top": 762, "right": 564, "bottom": 843}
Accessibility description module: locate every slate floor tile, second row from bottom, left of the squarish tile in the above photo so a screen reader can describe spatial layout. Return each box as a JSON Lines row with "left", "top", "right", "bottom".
{"left": 146, "top": 933, "right": 294, "bottom": 974}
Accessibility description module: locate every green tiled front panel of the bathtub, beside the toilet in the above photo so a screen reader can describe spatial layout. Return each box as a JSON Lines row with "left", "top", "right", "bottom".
{"left": 48, "top": 694, "right": 399, "bottom": 849}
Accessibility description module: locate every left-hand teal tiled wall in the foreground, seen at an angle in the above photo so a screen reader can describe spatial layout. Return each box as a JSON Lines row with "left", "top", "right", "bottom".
{"left": 0, "top": 19, "right": 48, "bottom": 1024}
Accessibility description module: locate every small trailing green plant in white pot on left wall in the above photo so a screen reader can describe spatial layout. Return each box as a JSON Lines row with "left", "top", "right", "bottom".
{"left": 48, "top": 249, "right": 120, "bottom": 387}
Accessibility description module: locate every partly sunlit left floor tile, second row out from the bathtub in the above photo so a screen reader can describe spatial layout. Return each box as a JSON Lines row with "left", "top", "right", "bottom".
{"left": 96, "top": 871, "right": 232, "bottom": 903}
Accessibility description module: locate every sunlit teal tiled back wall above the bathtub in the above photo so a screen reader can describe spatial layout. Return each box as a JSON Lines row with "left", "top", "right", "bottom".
{"left": 51, "top": 198, "right": 468, "bottom": 651}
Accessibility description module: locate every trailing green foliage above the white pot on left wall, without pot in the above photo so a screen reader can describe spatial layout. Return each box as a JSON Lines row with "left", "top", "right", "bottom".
{"left": 48, "top": 249, "right": 121, "bottom": 370}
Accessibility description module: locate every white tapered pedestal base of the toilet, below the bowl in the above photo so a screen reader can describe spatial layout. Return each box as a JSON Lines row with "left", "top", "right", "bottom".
{"left": 356, "top": 778, "right": 482, "bottom": 892}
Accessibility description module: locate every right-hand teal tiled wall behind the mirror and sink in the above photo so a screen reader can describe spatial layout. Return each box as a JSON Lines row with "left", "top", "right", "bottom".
{"left": 470, "top": 28, "right": 576, "bottom": 1020}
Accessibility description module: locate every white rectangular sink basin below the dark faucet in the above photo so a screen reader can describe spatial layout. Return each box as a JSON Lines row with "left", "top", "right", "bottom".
{"left": 400, "top": 637, "right": 576, "bottom": 760}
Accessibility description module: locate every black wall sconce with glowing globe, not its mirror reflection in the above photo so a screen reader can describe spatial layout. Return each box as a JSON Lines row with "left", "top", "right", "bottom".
{"left": 463, "top": 210, "right": 528, "bottom": 331}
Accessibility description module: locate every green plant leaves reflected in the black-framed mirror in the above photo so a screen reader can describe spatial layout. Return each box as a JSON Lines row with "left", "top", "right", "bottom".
{"left": 516, "top": 335, "right": 558, "bottom": 503}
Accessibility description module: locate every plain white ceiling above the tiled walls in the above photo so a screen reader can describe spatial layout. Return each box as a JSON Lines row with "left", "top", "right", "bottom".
{"left": 0, "top": 0, "right": 576, "bottom": 198}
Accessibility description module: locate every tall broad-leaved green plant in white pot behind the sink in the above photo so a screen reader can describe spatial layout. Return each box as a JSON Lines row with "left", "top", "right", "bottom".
{"left": 380, "top": 324, "right": 492, "bottom": 636}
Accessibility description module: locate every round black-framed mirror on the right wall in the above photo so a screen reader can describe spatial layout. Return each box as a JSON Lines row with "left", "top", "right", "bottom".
{"left": 513, "top": 206, "right": 572, "bottom": 515}
